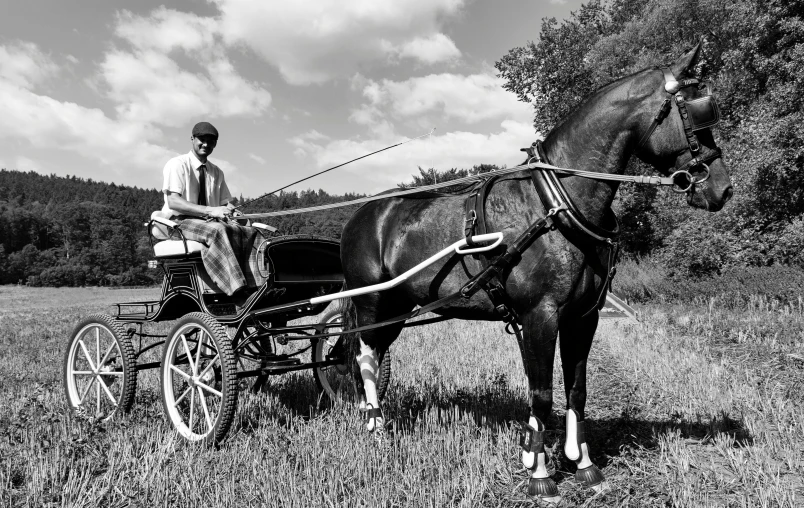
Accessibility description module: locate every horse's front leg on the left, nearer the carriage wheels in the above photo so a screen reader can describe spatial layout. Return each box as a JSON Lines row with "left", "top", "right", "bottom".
{"left": 522, "top": 301, "right": 561, "bottom": 503}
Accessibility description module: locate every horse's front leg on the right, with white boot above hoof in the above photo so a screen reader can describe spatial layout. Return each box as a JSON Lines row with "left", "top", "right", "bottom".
{"left": 560, "top": 312, "right": 607, "bottom": 492}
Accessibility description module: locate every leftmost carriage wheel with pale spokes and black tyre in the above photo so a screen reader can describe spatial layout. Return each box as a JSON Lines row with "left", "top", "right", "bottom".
{"left": 64, "top": 314, "right": 137, "bottom": 421}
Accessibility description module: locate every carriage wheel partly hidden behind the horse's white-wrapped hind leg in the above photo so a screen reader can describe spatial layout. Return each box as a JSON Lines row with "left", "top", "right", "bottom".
{"left": 313, "top": 309, "right": 391, "bottom": 401}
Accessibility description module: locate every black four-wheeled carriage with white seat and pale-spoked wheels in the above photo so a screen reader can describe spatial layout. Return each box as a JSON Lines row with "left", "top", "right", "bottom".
{"left": 63, "top": 212, "right": 502, "bottom": 442}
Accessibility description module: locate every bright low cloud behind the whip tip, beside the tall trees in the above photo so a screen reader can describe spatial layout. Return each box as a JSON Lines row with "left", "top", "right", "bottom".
{"left": 289, "top": 74, "right": 537, "bottom": 192}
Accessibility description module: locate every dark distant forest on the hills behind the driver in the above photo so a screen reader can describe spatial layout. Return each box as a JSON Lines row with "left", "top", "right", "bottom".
{"left": 0, "top": 169, "right": 370, "bottom": 286}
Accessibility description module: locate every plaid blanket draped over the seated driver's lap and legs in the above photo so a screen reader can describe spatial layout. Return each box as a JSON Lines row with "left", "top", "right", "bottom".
{"left": 177, "top": 218, "right": 265, "bottom": 296}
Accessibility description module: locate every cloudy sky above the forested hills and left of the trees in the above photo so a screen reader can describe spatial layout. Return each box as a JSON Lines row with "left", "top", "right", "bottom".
{"left": 0, "top": 0, "right": 581, "bottom": 197}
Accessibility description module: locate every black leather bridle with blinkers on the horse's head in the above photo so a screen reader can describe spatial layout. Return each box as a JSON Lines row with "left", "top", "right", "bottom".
{"left": 637, "top": 67, "right": 721, "bottom": 193}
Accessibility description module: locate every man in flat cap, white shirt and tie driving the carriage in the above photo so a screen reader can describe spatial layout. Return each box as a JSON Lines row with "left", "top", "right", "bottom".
{"left": 162, "top": 122, "right": 264, "bottom": 299}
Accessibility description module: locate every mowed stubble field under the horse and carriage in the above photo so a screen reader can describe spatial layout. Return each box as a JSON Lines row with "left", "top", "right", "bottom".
{"left": 0, "top": 287, "right": 804, "bottom": 507}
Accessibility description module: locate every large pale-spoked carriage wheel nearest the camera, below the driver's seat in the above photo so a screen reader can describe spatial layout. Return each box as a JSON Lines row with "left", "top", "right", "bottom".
{"left": 160, "top": 312, "right": 238, "bottom": 443}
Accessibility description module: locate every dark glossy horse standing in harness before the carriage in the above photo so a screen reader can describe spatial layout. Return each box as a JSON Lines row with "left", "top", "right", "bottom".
{"left": 341, "top": 46, "right": 733, "bottom": 501}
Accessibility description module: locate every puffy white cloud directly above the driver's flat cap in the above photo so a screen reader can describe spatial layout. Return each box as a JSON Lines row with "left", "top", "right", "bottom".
{"left": 99, "top": 7, "right": 271, "bottom": 127}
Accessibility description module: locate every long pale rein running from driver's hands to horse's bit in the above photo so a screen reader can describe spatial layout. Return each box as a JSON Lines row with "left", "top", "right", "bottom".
{"left": 237, "top": 159, "right": 684, "bottom": 219}
